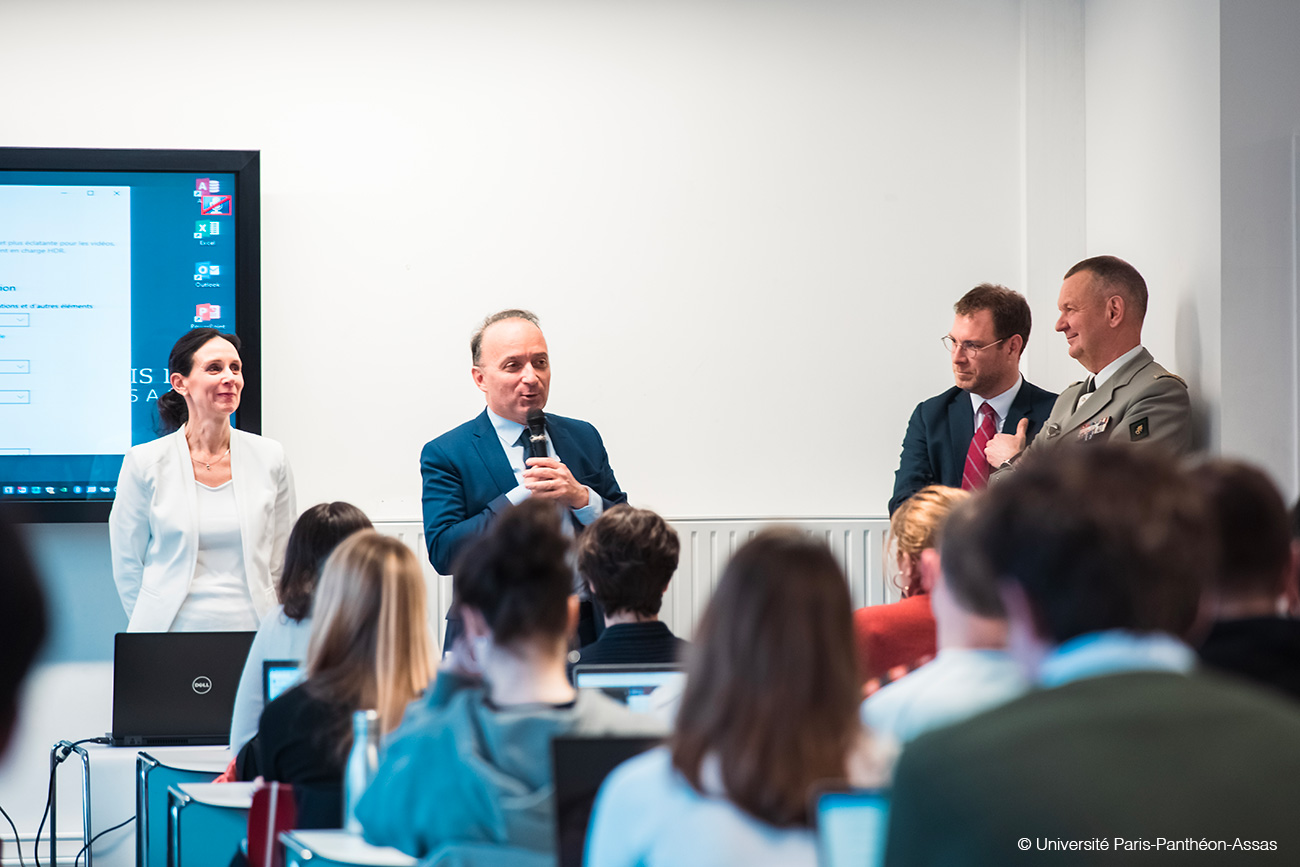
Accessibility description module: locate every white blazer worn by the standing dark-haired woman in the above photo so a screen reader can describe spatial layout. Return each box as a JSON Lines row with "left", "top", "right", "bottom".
{"left": 108, "top": 425, "right": 298, "bottom": 632}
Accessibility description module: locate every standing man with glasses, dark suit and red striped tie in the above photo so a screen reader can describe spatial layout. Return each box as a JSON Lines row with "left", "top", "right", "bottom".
{"left": 889, "top": 283, "right": 1056, "bottom": 515}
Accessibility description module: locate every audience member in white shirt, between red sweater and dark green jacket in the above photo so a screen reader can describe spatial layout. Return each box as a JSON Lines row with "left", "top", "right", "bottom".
{"left": 862, "top": 497, "right": 1028, "bottom": 742}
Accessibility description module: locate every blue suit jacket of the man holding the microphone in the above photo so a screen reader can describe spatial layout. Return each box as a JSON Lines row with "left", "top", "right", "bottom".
{"left": 420, "top": 409, "right": 628, "bottom": 575}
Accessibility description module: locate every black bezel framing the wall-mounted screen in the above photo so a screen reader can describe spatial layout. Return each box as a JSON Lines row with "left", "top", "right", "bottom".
{"left": 0, "top": 147, "right": 261, "bottom": 524}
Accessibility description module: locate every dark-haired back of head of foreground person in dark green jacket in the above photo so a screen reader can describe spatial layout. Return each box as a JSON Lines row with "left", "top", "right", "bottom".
{"left": 945, "top": 446, "right": 1218, "bottom": 645}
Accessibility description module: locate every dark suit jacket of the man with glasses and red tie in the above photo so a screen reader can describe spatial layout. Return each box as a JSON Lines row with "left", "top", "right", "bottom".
{"left": 889, "top": 380, "right": 1056, "bottom": 515}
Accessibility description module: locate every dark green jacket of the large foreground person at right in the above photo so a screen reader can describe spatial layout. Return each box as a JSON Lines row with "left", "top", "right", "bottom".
{"left": 885, "top": 672, "right": 1300, "bottom": 867}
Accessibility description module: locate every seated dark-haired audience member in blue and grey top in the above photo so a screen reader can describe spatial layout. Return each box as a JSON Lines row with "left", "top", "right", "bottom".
{"left": 358, "top": 499, "right": 664, "bottom": 862}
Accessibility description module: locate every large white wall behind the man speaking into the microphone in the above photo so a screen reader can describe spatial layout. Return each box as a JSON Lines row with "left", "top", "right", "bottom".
{"left": 0, "top": 0, "right": 1022, "bottom": 520}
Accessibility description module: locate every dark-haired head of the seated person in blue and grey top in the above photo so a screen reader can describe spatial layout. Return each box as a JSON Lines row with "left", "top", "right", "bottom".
{"left": 452, "top": 499, "right": 573, "bottom": 647}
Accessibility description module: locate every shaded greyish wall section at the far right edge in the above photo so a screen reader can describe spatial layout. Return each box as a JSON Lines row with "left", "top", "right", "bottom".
{"left": 1218, "top": 0, "right": 1300, "bottom": 498}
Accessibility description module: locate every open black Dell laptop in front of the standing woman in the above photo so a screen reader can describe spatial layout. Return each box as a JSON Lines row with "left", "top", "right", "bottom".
{"left": 108, "top": 632, "right": 256, "bottom": 746}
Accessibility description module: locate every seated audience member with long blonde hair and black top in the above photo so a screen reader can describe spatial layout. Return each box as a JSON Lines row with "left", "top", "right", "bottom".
{"left": 243, "top": 530, "right": 433, "bottom": 828}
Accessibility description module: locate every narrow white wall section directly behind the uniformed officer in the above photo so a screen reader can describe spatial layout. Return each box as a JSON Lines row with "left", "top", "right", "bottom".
{"left": 1075, "top": 0, "right": 1222, "bottom": 448}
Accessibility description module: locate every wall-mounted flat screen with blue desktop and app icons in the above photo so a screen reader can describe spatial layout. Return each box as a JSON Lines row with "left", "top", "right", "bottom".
{"left": 0, "top": 148, "right": 260, "bottom": 521}
